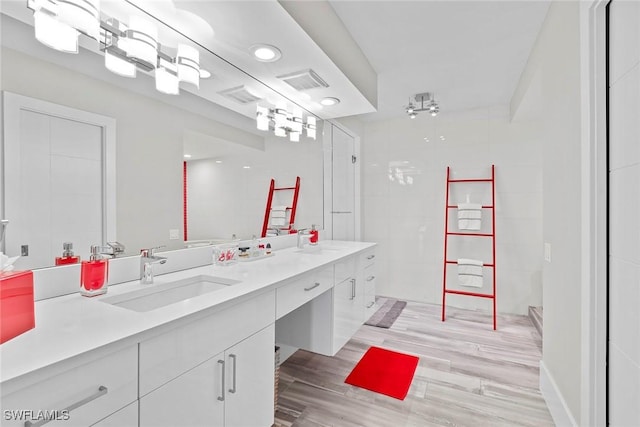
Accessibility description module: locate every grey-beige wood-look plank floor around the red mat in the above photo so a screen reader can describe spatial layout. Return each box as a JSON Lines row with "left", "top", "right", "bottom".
{"left": 275, "top": 302, "right": 553, "bottom": 427}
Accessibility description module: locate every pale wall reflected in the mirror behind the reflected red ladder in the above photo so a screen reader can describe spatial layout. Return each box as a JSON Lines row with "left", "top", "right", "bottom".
{"left": 187, "top": 132, "right": 323, "bottom": 240}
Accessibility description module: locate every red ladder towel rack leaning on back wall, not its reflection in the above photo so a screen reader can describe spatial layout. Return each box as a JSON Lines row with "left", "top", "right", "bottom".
{"left": 442, "top": 165, "right": 496, "bottom": 330}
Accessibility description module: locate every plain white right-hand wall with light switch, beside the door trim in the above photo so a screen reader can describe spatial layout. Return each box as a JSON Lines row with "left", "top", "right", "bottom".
{"left": 511, "top": 1, "right": 582, "bottom": 425}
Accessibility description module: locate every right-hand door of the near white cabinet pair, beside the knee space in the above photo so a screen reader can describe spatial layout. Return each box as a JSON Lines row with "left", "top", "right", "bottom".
{"left": 225, "top": 325, "right": 275, "bottom": 427}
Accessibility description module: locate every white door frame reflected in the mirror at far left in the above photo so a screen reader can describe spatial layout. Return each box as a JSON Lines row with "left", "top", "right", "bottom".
{"left": 0, "top": 91, "right": 116, "bottom": 260}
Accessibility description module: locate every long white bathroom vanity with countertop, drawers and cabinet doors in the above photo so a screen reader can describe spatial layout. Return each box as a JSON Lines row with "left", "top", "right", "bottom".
{"left": 0, "top": 241, "right": 375, "bottom": 427}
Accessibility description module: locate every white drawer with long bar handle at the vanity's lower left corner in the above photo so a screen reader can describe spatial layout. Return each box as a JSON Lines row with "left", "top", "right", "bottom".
{"left": 2, "top": 345, "right": 138, "bottom": 427}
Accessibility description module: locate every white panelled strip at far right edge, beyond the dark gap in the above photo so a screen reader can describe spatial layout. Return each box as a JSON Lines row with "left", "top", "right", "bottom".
{"left": 608, "top": 0, "right": 640, "bottom": 426}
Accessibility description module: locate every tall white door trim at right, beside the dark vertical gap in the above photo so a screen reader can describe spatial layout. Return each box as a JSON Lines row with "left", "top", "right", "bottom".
{"left": 580, "top": 0, "right": 609, "bottom": 425}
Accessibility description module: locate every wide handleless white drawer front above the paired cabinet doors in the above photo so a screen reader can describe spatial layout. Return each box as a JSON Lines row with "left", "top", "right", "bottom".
{"left": 139, "top": 291, "right": 275, "bottom": 397}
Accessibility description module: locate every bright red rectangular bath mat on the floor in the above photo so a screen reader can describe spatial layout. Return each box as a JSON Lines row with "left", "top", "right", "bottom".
{"left": 344, "top": 347, "right": 420, "bottom": 400}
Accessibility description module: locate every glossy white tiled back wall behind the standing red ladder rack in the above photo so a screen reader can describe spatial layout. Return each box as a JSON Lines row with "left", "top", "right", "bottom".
{"left": 362, "top": 107, "right": 542, "bottom": 316}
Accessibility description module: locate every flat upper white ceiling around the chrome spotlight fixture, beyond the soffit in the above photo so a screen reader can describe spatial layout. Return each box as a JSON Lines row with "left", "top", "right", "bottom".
{"left": 330, "top": 0, "right": 549, "bottom": 120}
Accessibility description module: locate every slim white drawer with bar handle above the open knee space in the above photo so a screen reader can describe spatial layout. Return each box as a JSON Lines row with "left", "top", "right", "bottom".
{"left": 276, "top": 266, "right": 333, "bottom": 319}
